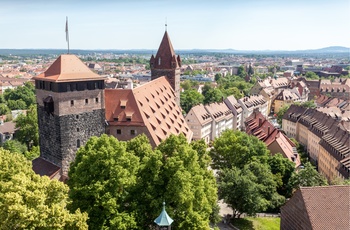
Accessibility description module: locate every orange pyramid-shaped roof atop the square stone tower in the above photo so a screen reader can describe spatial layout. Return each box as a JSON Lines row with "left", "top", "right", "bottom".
{"left": 33, "top": 54, "right": 104, "bottom": 82}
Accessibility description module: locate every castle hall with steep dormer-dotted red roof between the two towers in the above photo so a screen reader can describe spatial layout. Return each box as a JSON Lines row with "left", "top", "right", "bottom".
{"left": 105, "top": 77, "right": 192, "bottom": 147}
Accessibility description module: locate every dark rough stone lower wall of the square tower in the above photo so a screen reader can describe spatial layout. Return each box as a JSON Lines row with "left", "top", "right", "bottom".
{"left": 38, "top": 105, "right": 105, "bottom": 175}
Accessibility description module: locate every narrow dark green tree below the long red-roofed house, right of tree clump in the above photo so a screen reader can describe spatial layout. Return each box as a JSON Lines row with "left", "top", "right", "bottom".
{"left": 268, "top": 153, "right": 295, "bottom": 198}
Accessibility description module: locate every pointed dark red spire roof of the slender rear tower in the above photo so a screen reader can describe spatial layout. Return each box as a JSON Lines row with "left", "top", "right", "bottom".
{"left": 151, "top": 31, "right": 181, "bottom": 69}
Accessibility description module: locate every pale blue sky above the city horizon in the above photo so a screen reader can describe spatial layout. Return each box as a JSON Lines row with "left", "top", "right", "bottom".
{"left": 0, "top": 0, "right": 350, "bottom": 50}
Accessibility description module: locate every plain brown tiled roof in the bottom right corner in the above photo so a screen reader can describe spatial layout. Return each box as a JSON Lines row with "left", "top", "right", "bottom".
{"left": 280, "top": 185, "right": 350, "bottom": 230}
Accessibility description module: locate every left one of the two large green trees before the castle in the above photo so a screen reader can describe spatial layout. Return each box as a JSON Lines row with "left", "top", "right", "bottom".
{"left": 68, "top": 134, "right": 139, "bottom": 229}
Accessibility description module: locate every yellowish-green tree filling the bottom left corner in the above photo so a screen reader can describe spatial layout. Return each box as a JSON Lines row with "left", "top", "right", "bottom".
{"left": 0, "top": 149, "right": 88, "bottom": 229}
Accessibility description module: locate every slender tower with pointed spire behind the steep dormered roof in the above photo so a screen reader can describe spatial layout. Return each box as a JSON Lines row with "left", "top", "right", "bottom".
{"left": 150, "top": 31, "right": 181, "bottom": 106}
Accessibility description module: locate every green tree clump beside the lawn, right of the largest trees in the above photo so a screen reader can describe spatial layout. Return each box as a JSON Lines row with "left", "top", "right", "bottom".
{"left": 211, "top": 130, "right": 285, "bottom": 217}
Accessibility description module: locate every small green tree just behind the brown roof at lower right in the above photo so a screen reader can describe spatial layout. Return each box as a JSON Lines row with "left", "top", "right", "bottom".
{"left": 289, "top": 162, "right": 327, "bottom": 190}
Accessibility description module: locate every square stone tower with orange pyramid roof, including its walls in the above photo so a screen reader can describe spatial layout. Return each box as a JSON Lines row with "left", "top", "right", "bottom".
{"left": 34, "top": 54, "right": 105, "bottom": 176}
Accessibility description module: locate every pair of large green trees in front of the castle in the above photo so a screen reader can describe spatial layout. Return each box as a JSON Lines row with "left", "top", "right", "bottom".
{"left": 68, "top": 135, "right": 217, "bottom": 229}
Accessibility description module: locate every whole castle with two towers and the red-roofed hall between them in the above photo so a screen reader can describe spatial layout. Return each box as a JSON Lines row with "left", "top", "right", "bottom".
{"left": 33, "top": 32, "right": 192, "bottom": 180}
